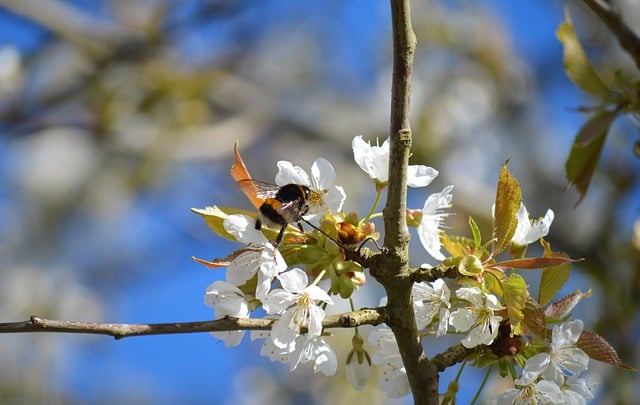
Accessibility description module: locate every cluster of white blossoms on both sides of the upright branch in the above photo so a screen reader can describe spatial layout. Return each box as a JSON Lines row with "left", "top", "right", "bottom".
{"left": 195, "top": 136, "right": 604, "bottom": 404}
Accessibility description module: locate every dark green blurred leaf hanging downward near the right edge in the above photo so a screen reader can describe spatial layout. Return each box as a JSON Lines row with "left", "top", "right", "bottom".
{"left": 564, "top": 110, "right": 618, "bottom": 203}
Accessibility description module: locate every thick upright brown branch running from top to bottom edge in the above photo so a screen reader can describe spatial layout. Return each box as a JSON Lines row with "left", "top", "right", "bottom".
{"left": 369, "top": 0, "right": 438, "bottom": 404}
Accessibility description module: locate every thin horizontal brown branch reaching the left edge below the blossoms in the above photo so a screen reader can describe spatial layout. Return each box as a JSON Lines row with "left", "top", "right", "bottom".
{"left": 0, "top": 308, "right": 385, "bottom": 339}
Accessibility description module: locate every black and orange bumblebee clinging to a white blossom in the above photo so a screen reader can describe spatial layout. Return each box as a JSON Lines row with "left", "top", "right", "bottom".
{"left": 238, "top": 179, "right": 319, "bottom": 246}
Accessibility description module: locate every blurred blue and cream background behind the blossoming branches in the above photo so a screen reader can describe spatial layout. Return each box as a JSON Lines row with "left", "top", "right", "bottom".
{"left": 0, "top": 0, "right": 640, "bottom": 405}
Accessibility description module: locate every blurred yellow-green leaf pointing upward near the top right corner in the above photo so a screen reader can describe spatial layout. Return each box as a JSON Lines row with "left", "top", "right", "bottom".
{"left": 556, "top": 9, "right": 610, "bottom": 96}
